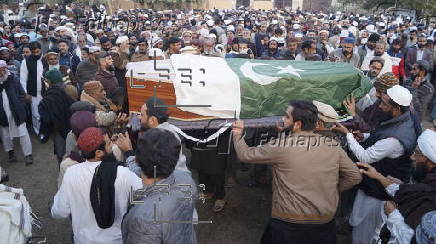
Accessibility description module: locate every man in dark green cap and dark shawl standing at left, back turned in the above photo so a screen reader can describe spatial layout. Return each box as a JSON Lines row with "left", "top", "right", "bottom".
{"left": 38, "top": 68, "right": 74, "bottom": 164}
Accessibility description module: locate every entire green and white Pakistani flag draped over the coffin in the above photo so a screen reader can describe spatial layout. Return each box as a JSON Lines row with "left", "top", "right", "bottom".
{"left": 171, "top": 54, "right": 371, "bottom": 118}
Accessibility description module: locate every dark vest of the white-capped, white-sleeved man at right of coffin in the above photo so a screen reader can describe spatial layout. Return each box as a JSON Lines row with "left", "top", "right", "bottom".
{"left": 359, "top": 112, "right": 417, "bottom": 200}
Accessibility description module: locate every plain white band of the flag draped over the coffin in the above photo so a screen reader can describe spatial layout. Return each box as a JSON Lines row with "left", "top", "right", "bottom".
{"left": 171, "top": 54, "right": 241, "bottom": 118}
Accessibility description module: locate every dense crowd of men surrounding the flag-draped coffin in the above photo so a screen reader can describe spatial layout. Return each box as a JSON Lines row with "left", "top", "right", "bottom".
{"left": 0, "top": 4, "right": 436, "bottom": 244}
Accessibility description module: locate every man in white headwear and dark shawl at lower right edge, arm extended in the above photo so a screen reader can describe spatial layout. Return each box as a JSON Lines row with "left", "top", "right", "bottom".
{"left": 358, "top": 127, "right": 436, "bottom": 243}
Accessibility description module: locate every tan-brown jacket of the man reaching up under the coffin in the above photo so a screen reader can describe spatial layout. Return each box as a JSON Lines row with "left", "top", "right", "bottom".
{"left": 233, "top": 132, "right": 362, "bottom": 224}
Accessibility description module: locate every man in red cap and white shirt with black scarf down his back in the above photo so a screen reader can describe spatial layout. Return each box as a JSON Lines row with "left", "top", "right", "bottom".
{"left": 51, "top": 127, "right": 142, "bottom": 244}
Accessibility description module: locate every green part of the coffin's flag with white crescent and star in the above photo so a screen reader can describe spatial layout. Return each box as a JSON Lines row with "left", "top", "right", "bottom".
{"left": 225, "top": 58, "right": 372, "bottom": 118}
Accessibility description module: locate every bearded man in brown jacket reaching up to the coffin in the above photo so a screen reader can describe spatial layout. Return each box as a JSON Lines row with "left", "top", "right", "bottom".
{"left": 233, "top": 100, "right": 362, "bottom": 244}
